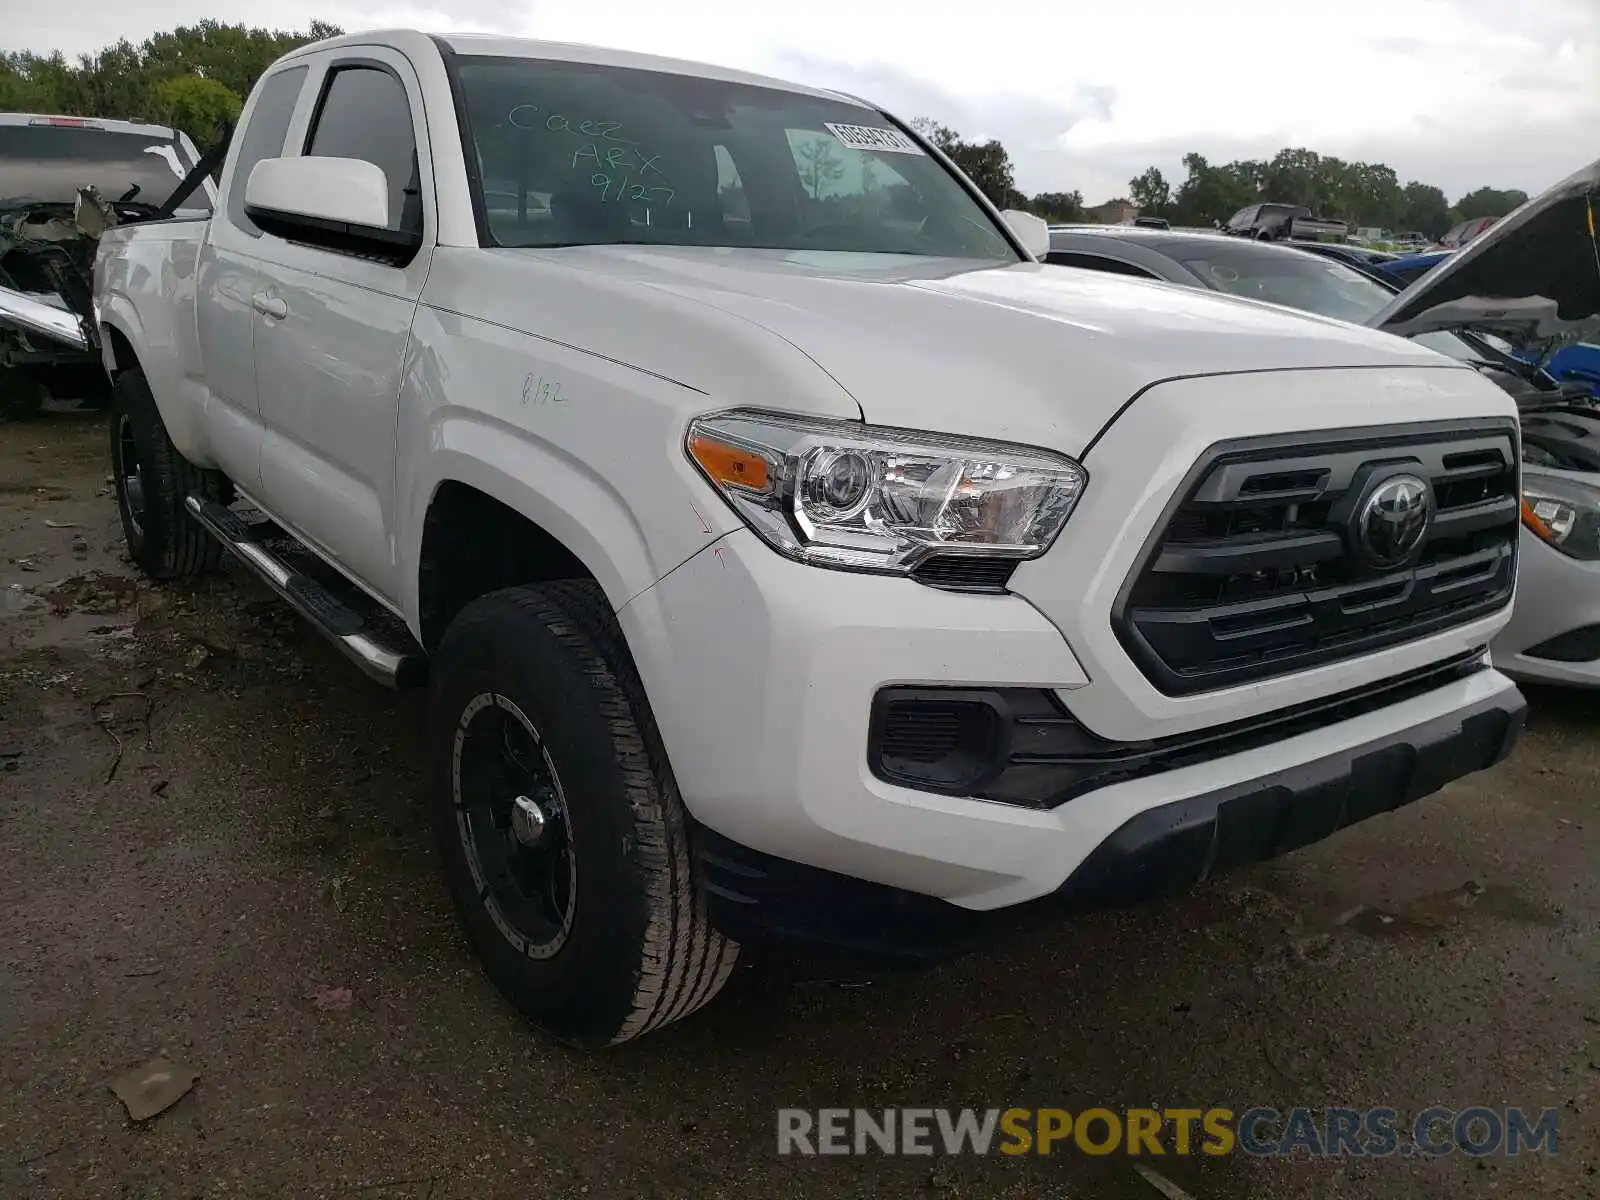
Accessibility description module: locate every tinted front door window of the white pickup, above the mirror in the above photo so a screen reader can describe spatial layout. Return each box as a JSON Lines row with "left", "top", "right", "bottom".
{"left": 306, "top": 67, "right": 422, "bottom": 232}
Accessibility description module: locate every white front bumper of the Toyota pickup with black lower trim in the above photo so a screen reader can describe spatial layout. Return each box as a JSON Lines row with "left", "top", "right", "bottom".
{"left": 619, "top": 531, "right": 1522, "bottom": 910}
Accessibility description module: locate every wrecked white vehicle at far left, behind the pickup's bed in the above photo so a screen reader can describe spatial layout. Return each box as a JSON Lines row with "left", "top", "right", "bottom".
{"left": 0, "top": 112, "right": 214, "bottom": 419}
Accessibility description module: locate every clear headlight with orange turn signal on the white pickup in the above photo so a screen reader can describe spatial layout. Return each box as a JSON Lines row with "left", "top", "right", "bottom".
{"left": 688, "top": 410, "right": 1088, "bottom": 573}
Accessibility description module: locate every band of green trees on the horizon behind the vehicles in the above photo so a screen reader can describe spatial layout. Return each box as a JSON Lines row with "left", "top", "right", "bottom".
{"left": 0, "top": 21, "right": 1528, "bottom": 238}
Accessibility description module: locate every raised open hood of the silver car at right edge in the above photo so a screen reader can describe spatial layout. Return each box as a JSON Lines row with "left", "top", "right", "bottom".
{"left": 1370, "top": 152, "right": 1600, "bottom": 342}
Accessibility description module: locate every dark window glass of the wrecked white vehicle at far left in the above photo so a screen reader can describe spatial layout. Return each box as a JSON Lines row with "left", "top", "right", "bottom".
{"left": 0, "top": 125, "right": 211, "bottom": 211}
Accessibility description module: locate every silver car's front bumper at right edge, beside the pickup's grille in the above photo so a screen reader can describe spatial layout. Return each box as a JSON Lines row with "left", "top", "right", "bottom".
{"left": 1490, "top": 530, "right": 1600, "bottom": 688}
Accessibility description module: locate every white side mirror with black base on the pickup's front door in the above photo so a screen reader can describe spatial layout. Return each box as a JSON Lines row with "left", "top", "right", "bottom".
{"left": 245, "top": 157, "right": 422, "bottom": 266}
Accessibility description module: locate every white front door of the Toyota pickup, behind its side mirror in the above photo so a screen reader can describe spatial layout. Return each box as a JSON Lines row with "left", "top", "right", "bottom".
{"left": 251, "top": 46, "right": 434, "bottom": 603}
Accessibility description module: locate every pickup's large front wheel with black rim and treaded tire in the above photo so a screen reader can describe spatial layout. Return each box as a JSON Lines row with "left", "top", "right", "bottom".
{"left": 427, "top": 581, "right": 739, "bottom": 1046}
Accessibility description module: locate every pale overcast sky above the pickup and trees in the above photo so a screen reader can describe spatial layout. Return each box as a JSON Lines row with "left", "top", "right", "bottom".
{"left": 0, "top": 0, "right": 1600, "bottom": 203}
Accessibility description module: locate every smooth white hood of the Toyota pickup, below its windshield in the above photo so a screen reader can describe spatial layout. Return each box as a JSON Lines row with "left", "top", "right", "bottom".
{"left": 510, "top": 246, "right": 1448, "bottom": 453}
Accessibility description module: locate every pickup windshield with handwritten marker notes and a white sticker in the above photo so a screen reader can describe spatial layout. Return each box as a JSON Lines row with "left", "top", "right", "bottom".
{"left": 454, "top": 56, "right": 1019, "bottom": 262}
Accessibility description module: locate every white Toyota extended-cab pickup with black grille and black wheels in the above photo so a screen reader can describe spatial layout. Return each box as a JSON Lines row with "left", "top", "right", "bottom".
{"left": 94, "top": 32, "right": 1523, "bottom": 1045}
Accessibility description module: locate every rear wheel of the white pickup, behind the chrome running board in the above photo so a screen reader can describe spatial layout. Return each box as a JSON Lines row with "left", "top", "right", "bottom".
{"left": 110, "top": 368, "right": 232, "bottom": 579}
